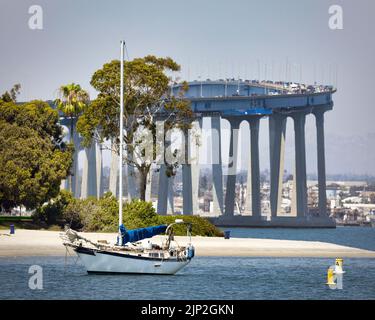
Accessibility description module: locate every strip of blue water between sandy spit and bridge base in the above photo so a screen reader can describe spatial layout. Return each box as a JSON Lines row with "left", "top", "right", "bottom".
{"left": 223, "top": 227, "right": 375, "bottom": 251}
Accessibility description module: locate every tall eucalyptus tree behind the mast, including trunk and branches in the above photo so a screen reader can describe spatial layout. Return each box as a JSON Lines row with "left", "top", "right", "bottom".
{"left": 77, "top": 55, "right": 193, "bottom": 200}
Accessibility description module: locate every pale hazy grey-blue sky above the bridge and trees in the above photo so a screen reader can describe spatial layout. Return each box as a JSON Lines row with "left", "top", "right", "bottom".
{"left": 0, "top": 0, "right": 375, "bottom": 174}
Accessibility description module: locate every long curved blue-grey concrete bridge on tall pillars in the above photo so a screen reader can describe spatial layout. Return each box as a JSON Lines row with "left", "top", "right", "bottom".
{"left": 59, "top": 80, "right": 335, "bottom": 227}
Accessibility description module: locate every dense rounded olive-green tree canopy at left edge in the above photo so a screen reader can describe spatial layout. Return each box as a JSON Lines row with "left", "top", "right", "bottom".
{"left": 0, "top": 101, "right": 72, "bottom": 209}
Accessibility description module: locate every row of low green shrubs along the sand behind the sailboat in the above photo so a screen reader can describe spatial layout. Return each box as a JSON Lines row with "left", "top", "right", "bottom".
{"left": 34, "top": 191, "right": 222, "bottom": 237}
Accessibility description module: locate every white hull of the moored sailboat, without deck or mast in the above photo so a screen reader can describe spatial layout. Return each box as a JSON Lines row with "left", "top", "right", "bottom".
{"left": 76, "top": 250, "right": 190, "bottom": 275}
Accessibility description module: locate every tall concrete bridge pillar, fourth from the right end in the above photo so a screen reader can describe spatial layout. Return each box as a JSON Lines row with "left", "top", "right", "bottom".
{"left": 246, "top": 117, "right": 261, "bottom": 218}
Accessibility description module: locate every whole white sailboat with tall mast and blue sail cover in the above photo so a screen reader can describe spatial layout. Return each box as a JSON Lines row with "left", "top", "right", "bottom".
{"left": 62, "top": 41, "right": 195, "bottom": 275}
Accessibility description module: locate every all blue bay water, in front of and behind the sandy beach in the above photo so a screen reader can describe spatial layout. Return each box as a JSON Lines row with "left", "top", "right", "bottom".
{"left": 0, "top": 227, "right": 375, "bottom": 300}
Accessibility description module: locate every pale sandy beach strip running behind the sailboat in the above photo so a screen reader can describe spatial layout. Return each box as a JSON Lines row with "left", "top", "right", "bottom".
{"left": 0, "top": 230, "right": 375, "bottom": 258}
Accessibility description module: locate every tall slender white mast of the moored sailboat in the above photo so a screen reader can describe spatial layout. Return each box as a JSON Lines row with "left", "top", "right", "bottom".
{"left": 118, "top": 40, "right": 125, "bottom": 232}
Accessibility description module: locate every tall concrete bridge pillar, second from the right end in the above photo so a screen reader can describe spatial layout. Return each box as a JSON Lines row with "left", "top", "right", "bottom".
{"left": 293, "top": 113, "right": 308, "bottom": 217}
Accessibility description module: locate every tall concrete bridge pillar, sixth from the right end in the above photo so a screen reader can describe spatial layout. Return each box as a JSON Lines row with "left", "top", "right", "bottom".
{"left": 211, "top": 116, "right": 224, "bottom": 215}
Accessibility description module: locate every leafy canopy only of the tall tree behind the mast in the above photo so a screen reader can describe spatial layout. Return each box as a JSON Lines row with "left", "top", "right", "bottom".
{"left": 77, "top": 56, "right": 193, "bottom": 145}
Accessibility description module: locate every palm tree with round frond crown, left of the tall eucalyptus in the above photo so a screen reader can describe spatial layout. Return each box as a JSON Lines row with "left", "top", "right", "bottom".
{"left": 55, "top": 83, "right": 89, "bottom": 192}
